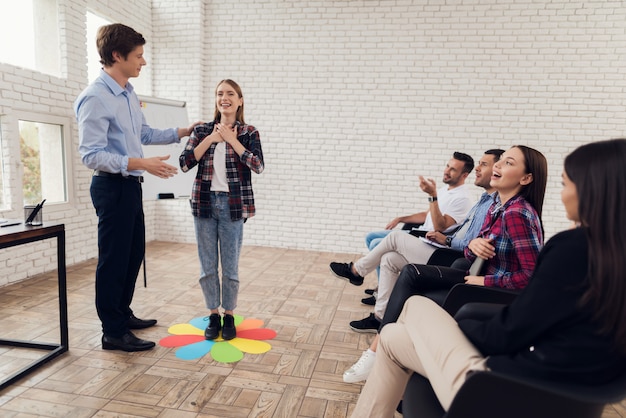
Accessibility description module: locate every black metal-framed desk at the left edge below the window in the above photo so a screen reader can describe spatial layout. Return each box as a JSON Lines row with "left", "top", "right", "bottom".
{"left": 0, "top": 223, "right": 69, "bottom": 390}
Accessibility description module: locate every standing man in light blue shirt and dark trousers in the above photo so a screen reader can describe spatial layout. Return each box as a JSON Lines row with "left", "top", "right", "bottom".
{"left": 74, "top": 23, "right": 196, "bottom": 351}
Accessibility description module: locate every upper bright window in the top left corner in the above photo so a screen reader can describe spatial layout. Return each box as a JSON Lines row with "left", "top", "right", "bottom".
{"left": 0, "top": 0, "right": 61, "bottom": 76}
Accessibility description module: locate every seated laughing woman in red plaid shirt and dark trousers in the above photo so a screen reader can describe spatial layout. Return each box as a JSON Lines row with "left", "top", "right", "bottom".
{"left": 343, "top": 145, "right": 548, "bottom": 383}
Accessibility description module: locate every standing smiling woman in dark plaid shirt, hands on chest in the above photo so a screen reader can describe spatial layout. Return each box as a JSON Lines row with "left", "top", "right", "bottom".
{"left": 179, "top": 80, "right": 264, "bottom": 340}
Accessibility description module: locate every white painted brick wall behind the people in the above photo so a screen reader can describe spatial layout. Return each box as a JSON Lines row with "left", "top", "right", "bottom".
{"left": 0, "top": 0, "right": 626, "bottom": 284}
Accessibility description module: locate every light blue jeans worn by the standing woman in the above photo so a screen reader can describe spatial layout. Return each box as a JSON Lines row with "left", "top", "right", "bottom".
{"left": 194, "top": 192, "right": 243, "bottom": 311}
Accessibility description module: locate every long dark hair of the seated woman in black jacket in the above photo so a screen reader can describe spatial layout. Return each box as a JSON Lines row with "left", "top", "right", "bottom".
{"left": 564, "top": 139, "right": 626, "bottom": 351}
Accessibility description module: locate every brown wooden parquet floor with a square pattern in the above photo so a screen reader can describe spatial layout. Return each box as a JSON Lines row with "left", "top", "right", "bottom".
{"left": 0, "top": 242, "right": 626, "bottom": 418}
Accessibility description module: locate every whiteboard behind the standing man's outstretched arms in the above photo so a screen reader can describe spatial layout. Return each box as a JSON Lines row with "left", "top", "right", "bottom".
{"left": 138, "top": 96, "right": 197, "bottom": 200}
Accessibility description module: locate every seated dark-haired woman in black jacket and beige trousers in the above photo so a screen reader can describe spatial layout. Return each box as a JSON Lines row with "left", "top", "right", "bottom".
{"left": 353, "top": 139, "right": 626, "bottom": 418}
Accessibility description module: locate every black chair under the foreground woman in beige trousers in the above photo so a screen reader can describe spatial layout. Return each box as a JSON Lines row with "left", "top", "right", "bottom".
{"left": 402, "top": 366, "right": 626, "bottom": 418}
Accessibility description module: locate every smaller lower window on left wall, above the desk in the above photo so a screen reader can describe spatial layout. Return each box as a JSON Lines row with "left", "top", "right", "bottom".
{"left": 17, "top": 113, "right": 71, "bottom": 205}
